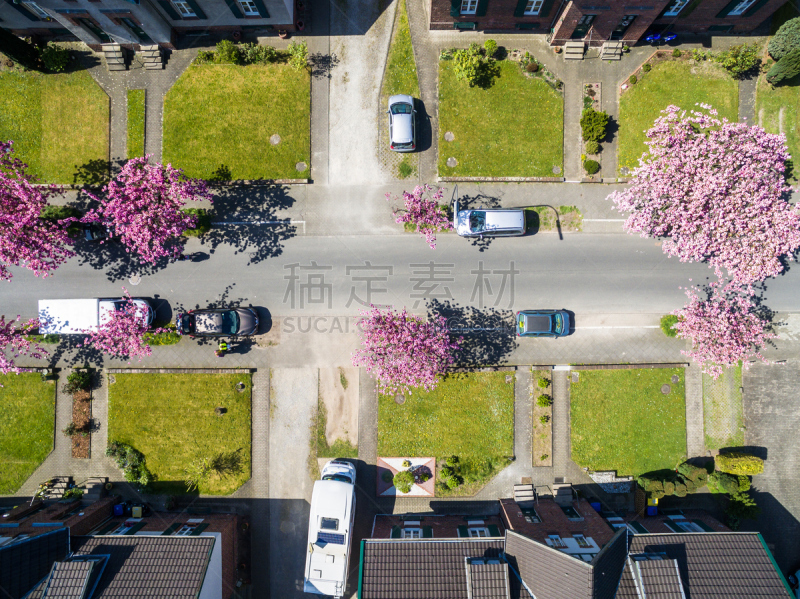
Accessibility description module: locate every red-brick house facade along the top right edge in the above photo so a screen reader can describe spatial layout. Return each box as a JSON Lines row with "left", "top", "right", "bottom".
{"left": 430, "top": 0, "right": 784, "bottom": 46}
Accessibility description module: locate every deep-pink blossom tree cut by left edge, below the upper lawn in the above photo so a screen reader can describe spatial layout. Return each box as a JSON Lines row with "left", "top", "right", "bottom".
{"left": 0, "top": 141, "right": 74, "bottom": 281}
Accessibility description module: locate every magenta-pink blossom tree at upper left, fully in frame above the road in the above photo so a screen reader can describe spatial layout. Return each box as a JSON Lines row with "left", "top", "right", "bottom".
{"left": 82, "top": 155, "right": 212, "bottom": 264}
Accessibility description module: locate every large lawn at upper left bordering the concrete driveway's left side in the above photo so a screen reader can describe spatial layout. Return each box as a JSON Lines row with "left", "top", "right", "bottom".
{"left": 163, "top": 63, "right": 311, "bottom": 180}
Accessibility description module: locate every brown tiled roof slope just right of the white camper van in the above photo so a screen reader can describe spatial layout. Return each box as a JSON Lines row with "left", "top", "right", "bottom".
{"left": 361, "top": 539, "right": 503, "bottom": 599}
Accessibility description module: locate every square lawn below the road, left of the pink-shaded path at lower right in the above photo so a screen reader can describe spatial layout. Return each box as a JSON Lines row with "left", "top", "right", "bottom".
{"left": 570, "top": 368, "right": 686, "bottom": 476}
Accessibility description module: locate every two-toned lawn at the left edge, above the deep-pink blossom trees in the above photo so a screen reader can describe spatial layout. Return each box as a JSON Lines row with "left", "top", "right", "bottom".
{"left": 0, "top": 71, "right": 109, "bottom": 183}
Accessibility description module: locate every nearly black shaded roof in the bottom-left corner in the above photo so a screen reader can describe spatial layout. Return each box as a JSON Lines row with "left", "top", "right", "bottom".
{"left": 0, "top": 528, "right": 69, "bottom": 599}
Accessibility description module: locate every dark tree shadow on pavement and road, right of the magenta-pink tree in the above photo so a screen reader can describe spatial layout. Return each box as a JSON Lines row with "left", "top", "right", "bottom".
{"left": 200, "top": 185, "right": 297, "bottom": 264}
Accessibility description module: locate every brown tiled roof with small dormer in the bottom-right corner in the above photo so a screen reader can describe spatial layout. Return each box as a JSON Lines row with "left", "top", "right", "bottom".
{"left": 617, "top": 532, "right": 791, "bottom": 599}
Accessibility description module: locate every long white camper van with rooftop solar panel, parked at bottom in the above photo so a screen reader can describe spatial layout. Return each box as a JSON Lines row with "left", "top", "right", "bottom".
{"left": 303, "top": 460, "right": 356, "bottom": 597}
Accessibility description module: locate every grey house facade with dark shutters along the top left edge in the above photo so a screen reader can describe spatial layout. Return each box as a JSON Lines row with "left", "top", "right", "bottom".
{"left": 0, "top": 0, "right": 296, "bottom": 50}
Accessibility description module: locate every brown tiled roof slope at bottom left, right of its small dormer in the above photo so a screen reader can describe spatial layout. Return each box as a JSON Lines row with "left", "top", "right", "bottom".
{"left": 72, "top": 536, "right": 214, "bottom": 599}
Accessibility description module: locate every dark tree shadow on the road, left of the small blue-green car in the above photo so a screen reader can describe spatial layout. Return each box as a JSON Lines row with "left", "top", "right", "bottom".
{"left": 428, "top": 300, "right": 517, "bottom": 366}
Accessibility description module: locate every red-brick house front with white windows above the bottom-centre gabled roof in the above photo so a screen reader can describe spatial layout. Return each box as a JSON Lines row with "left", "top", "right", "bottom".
{"left": 500, "top": 498, "right": 614, "bottom": 547}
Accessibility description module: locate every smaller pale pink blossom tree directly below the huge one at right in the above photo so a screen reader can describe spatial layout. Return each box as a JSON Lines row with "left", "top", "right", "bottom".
{"left": 673, "top": 282, "right": 775, "bottom": 379}
